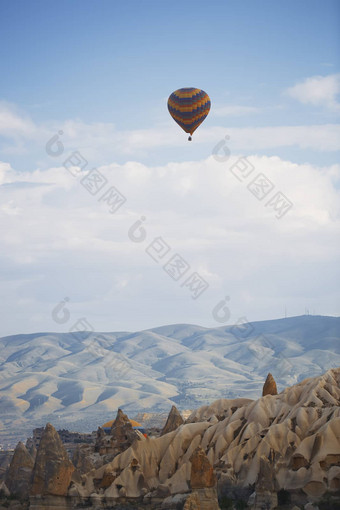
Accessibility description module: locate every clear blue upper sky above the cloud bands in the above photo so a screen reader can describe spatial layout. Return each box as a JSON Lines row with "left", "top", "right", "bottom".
{"left": 0, "top": 0, "right": 340, "bottom": 167}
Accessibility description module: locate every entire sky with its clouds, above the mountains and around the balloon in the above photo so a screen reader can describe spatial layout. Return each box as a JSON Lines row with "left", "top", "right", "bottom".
{"left": 0, "top": 0, "right": 340, "bottom": 334}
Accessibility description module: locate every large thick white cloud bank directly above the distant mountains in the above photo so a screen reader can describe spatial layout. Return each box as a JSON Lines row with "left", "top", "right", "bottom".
{"left": 0, "top": 156, "right": 340, "bottom": 335}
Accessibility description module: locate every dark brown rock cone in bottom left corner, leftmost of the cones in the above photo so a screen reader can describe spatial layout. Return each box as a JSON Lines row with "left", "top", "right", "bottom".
{"left": 5, "top": 441, "right": 34, "bottom": 497}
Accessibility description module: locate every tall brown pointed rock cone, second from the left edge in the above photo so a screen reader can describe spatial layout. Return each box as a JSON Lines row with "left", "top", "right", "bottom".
{"left": 31, "top": 423, "right": 74, "bottom": 496}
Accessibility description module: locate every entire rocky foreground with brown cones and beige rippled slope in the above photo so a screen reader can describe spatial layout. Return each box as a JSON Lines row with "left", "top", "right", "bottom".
{"left": 0, "top": 368, "right": 340, "bottom": 510}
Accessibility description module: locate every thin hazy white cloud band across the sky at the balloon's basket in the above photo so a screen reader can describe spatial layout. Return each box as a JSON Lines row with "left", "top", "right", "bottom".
{"left": 0, "top": 106, "right": 340, "bottom": 166}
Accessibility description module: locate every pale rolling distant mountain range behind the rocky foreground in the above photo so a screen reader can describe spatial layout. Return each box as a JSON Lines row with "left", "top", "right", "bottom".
{"left": 0, "top": 316, "right": 340, "bottom": 442}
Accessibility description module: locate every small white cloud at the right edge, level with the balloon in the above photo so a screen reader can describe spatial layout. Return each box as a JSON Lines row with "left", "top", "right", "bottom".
{"left": 286, "top": 73, "right": 340, "bottom": 111}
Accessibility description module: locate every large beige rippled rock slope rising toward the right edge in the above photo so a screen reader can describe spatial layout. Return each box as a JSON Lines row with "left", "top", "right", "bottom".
{"left": 68, "top": 368, "right": 340, "bottom": 501}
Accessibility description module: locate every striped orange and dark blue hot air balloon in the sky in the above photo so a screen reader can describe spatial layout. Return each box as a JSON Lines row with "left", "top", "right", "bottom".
{"left": 168, "top": 87, "right": 211, "bottom": 140}
